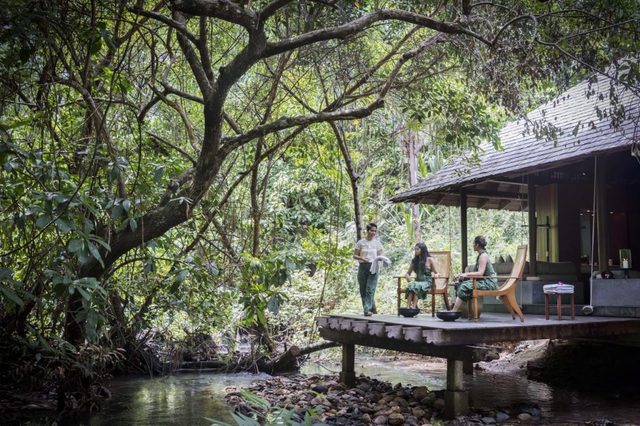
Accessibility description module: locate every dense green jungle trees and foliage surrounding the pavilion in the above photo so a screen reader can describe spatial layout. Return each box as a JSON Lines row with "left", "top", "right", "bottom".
{"left": 0, "top": 0, "right": 639, "bottom": 410}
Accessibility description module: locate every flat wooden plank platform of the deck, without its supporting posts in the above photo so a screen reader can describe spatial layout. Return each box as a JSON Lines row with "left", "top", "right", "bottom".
{"left": 317, "top": 313, "right": 640, "bottom": 346}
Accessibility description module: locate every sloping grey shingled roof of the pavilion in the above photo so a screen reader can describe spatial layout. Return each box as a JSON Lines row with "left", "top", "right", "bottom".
{"left": 391, "top": 69, "right": 640, "bottom": 204}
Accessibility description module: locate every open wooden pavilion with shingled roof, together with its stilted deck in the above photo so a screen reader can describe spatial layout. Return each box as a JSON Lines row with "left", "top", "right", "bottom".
{"left": 316, "top": 69, "right": 640, "bottom": 418}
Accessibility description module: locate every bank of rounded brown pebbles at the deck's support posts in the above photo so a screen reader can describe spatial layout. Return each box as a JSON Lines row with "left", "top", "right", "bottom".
{"left": 225, "top": 374, "right": 541, "bottom": 426}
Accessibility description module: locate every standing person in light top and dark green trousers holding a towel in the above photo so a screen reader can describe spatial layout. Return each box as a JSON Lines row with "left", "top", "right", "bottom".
{"left": 353, "top": 223, "right": 382, "bottom": 317}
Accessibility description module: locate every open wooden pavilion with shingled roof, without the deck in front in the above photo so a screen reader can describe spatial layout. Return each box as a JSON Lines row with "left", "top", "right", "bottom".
{"left": 392, "top": 66, "right": 640, "bottom": 317}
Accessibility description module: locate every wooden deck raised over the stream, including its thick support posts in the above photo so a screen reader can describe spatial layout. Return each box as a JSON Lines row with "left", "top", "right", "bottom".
{"left": 316, "top": 312, "right": 640, "bottom": 418}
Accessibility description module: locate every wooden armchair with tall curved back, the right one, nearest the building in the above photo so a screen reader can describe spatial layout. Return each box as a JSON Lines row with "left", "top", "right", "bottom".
{"left": 467, "top": 245, "right": 527, "bottom": 322}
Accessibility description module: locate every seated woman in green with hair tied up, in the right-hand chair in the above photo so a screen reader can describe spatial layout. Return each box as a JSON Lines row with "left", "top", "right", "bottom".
{"left": 452, "top": 235, "right": 498, "bottom": 311}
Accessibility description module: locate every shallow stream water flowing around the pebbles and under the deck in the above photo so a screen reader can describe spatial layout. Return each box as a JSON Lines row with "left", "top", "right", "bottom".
{"left": 59, "top": 357, "right": 640, "bottom": 426}
